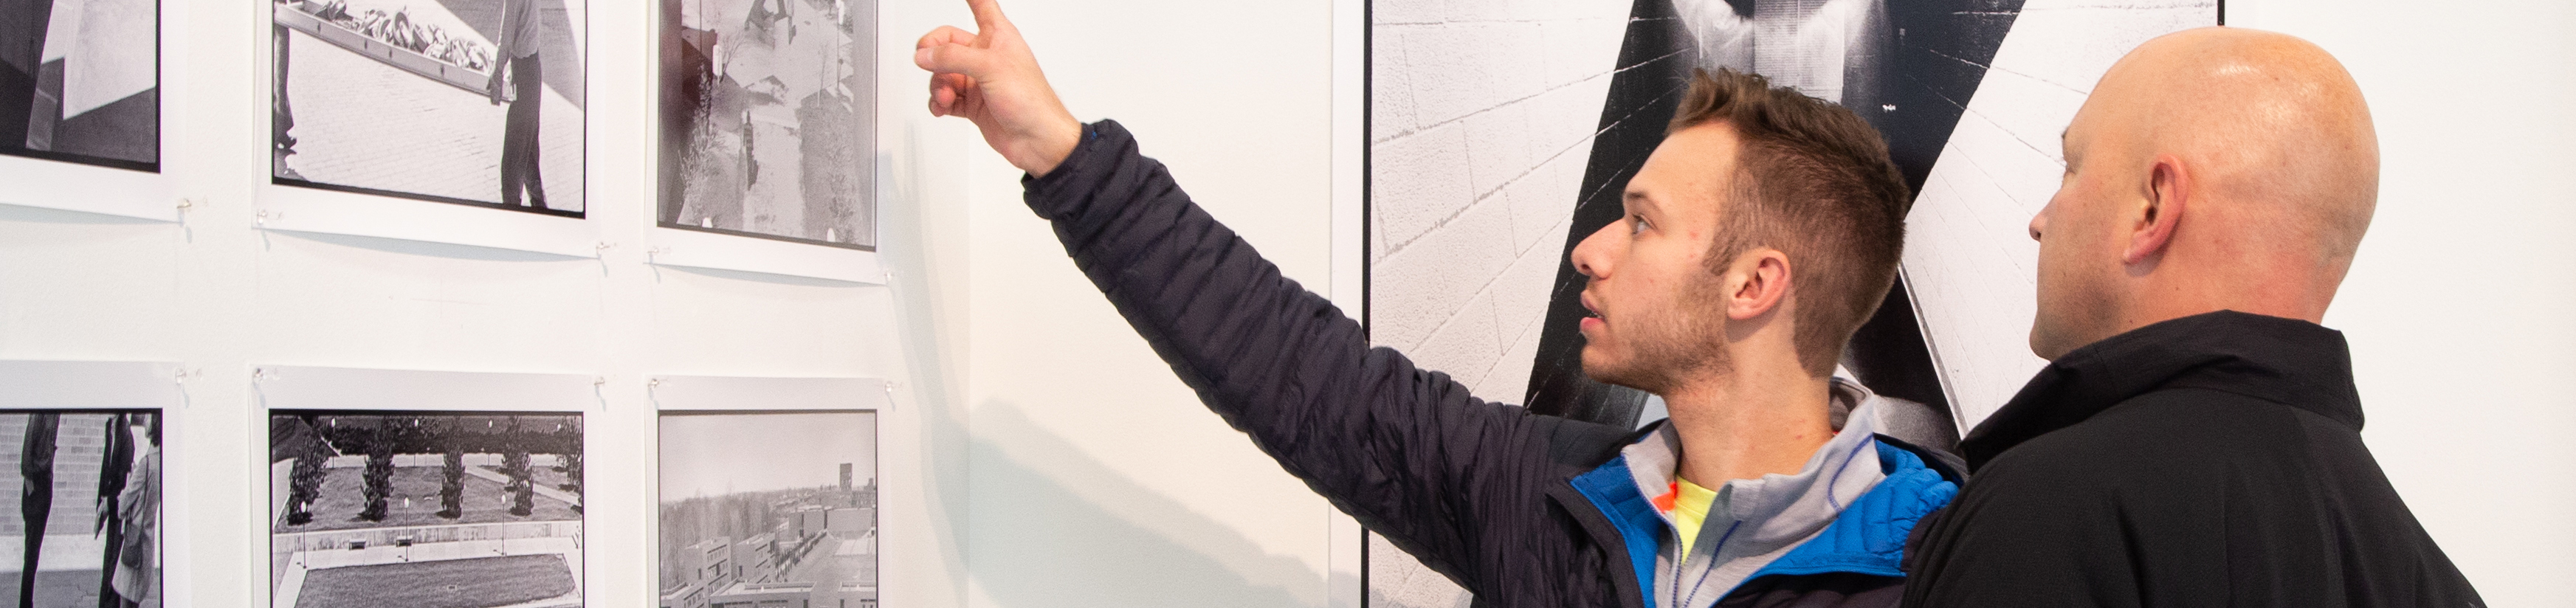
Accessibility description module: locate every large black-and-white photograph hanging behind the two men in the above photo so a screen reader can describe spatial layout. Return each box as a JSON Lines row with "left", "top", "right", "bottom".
{"left": 1363, "top": 0, "right": 2215, "bottom": 608}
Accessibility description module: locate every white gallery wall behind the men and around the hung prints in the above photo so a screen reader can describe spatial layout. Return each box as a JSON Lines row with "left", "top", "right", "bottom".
{"left": 0, "top": 0, "right": 2576, "bottom": 608}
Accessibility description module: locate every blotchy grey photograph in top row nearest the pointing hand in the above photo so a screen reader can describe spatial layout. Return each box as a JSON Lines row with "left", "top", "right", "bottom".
{"left": 659, "top": 0, "right": 876, "bottom": 250}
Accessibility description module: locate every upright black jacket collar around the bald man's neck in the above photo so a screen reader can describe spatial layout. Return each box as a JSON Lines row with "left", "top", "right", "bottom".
{"left": 1957, "top": 311, "right": 2362, "bottom": 469}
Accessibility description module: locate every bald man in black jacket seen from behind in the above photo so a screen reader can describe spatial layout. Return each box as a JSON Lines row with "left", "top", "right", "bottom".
{"left": 1907, "top": 28, "right": 2483, "bottom": 606}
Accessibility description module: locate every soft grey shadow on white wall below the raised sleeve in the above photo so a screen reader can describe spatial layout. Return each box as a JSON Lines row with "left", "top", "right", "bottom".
{"left": 966, "top": 402, "right": 1324, "bottom": 608}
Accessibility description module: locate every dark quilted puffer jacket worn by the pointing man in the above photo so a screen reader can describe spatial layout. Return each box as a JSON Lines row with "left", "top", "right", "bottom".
{"left": 1023, "top": 121, "right": 1955, "bottom": 608}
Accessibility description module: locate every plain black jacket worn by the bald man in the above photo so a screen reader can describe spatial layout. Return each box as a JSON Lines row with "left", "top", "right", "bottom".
{"left": 1907, "top": 311, "right": 2483, "bottom": 606}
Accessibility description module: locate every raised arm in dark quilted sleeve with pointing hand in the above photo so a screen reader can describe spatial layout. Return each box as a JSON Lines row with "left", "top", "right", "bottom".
{"left": 915, "top": 0, "right": 1623, "bottom": 587}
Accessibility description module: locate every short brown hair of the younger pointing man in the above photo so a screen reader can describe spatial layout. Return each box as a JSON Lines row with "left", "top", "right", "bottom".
{"left": 1664, "top": 69, "right": 1914, "bottom": 376}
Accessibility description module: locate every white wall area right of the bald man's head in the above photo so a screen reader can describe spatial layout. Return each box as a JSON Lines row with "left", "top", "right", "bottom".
{"left": 2228, "top": 0, "right": 2576, "bottom": 606}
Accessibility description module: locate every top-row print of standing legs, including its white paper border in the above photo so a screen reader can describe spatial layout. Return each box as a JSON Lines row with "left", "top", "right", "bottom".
{"left": 255, "top": 0, "right": 600, "bottom": 258}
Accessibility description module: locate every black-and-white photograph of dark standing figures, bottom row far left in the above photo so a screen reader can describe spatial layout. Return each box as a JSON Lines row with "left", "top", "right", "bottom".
{"left": 0, "top": 410, "right": 162, "bottom": 608}
